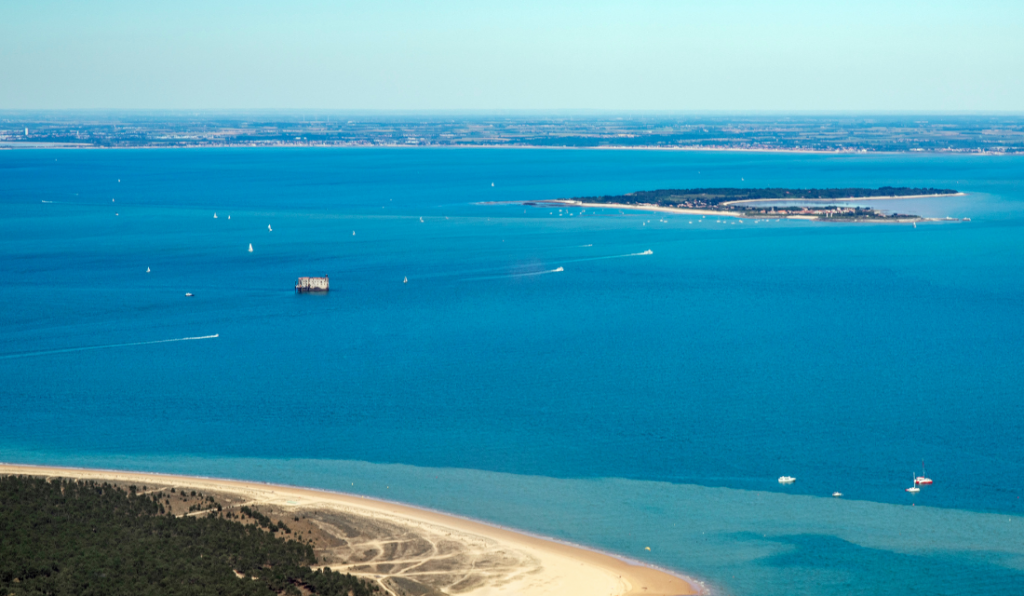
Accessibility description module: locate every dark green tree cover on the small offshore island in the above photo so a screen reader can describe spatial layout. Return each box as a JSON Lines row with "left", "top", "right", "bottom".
{"left": 573, "top": 186, "right": 957, "bottom": 207}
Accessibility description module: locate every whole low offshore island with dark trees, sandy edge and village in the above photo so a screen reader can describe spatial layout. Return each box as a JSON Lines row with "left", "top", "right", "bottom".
{"left": 528, "top": 186, "right": 959, "bottom": 221}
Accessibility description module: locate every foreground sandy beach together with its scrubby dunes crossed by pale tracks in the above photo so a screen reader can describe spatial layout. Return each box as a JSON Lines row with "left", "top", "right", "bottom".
{"left": 0, "top": 464, "right": 698, "bottom": 596}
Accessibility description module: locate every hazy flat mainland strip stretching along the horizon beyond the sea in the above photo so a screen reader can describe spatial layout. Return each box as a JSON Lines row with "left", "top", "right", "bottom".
{"left": 0, "top": 112, "right": 1024, "bottom": 154}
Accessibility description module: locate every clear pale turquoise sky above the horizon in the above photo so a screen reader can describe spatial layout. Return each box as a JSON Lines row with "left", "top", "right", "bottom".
{"left": 0, "top": 0, "right": 1024, "bottom": 113}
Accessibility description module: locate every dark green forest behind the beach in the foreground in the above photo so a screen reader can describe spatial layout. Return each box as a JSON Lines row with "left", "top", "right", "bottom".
{"left": 0, "top": 476, "right": 377, "bottom": 596}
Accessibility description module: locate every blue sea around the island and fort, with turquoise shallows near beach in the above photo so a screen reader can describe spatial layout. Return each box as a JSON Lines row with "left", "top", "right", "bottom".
{"left": 0, "top": 150, "right": 1024, "bottom": 596}
